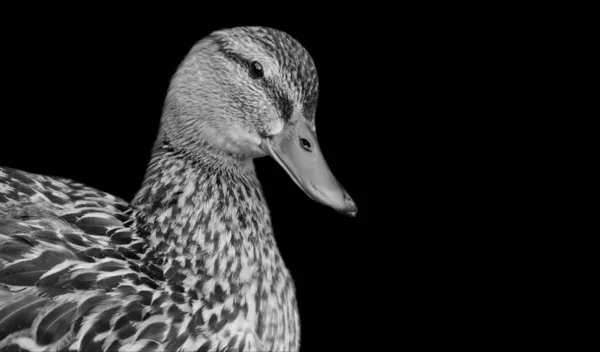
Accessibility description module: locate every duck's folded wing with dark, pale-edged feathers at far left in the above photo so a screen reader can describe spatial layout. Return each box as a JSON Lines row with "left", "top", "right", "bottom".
{"left": 0, "top": 168, "right": 155, "bottom": 351}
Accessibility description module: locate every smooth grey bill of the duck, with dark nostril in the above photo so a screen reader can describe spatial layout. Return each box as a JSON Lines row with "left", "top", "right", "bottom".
{"left": 262, "top": 115, "right": 358, "bottom": 216}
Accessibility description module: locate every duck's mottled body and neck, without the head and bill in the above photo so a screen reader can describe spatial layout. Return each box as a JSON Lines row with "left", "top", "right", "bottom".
{"left": 0, "top": 151, "right": 299, "bottom": 351}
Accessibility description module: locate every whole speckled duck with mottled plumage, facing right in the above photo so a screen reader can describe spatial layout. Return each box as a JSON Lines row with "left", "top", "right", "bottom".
{"left": 0, "top": 27, "right": 357, "bottom": 352}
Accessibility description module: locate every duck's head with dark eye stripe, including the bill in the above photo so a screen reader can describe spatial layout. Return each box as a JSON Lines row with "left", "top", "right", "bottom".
{"left": 161, "top": 27, "right": 357, "bottom": 216}
